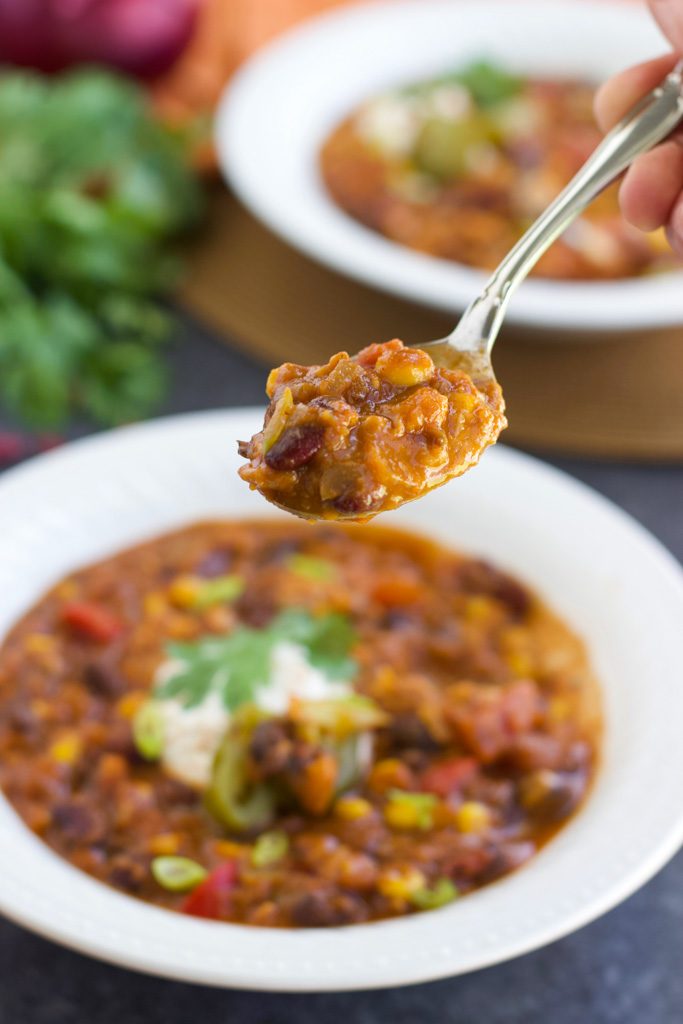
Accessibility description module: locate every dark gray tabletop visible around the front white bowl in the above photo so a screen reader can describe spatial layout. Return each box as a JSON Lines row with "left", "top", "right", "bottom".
{"left": 0, "top": 315, "right": 683, "bottom": 1024}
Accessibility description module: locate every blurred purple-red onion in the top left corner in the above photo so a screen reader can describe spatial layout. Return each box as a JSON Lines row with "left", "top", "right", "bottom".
{"left": 0, "top": 0, "right": 203, "bottom": 78}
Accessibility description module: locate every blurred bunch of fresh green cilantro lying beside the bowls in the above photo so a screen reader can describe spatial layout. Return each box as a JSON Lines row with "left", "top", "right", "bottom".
{"left": 0, "top": 70, "right": 201, "bottom": 427}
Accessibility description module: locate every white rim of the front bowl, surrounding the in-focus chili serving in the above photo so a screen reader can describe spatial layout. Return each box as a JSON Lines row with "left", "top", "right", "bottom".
{"left": 0, "top": 411, "right": 683, "bottom": 990}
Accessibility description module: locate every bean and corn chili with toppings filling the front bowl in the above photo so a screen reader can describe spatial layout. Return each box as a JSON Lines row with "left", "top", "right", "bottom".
{"left": 0, "top": 520, "right": 600, "bottom": 928}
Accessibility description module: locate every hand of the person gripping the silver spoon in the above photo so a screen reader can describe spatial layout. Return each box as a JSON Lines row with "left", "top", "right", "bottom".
{"left": 595, "top": 0, "right": 683, "bottom": 256}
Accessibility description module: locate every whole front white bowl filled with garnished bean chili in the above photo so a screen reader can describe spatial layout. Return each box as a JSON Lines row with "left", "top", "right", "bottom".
{"left": 0, "top": 411, "right": 683, "bottom": 990}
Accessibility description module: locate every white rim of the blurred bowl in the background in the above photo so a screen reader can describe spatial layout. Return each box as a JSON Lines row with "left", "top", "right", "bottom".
{"left": 216, "top": 0, "right": 683, "bottom": 332}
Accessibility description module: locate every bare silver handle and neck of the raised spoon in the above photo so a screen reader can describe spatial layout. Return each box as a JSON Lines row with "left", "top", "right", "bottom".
{"left": 418, "top": 60, "right": 683, "bottom": 385}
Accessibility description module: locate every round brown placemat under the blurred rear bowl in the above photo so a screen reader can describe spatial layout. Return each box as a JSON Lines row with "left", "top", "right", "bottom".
{"left": 181, "top": 187, "right": 683, "bottom": 461}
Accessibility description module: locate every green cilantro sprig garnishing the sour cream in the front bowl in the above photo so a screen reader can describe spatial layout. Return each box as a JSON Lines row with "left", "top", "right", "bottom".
{"left": 155, "top": 608, "right": 357, "bottom": 711}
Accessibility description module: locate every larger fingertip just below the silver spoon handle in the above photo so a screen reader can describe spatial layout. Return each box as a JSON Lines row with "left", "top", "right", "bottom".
{"left": 620, "top": 141, "right": 683, "bottom": 231}
